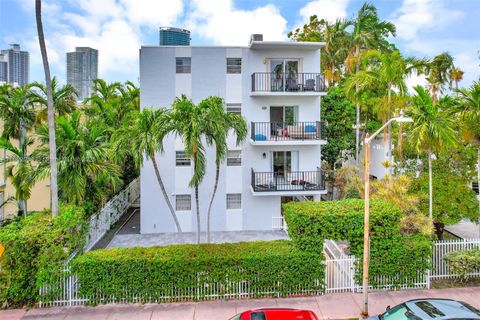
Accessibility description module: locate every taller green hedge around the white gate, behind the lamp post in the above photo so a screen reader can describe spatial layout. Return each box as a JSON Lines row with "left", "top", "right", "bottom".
{"left": 283, "top": 199, "right": 432, "bottom": 286}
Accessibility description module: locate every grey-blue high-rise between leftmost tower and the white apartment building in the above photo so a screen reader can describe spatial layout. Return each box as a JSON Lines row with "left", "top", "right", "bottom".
{"left": 67, "top": 47, "right": 98, "bottom": 100}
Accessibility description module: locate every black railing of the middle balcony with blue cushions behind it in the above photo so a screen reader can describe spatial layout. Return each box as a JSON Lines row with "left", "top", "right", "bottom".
{"left": 250, "top": 121, "right": 325, "bottom": 141}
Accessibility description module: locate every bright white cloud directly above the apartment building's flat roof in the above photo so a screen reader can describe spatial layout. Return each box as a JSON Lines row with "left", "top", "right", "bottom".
{"left": 187, "top": 0, "right": 287, "bottom": 45}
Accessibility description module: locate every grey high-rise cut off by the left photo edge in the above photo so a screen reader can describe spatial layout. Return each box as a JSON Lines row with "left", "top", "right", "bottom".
{"left": 0, "top": 44, "right": 30, "bottom": 86}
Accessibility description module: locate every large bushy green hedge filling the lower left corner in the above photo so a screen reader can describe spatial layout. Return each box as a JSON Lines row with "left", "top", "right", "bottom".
{"left": 0, "top": 206, "right": 85, "bottom": 307}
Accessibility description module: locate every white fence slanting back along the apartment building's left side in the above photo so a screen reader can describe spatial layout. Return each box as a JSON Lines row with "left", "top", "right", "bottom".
{"left": 85, "top": 178, "right": 140, "bottom": 251}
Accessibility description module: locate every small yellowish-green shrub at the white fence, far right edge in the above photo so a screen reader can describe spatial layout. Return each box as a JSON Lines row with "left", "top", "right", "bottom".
{"left": 445, "top": 249, "right": 480, "bottom": 282}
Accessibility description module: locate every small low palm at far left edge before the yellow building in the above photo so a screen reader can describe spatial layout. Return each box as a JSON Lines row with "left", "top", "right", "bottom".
{"left": 0, "top": 137, "right": 36, "bottom": 216}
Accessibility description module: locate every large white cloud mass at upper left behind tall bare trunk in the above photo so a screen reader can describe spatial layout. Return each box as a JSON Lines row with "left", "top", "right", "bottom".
{"left": 22, "top": 0, "right": 187, "bottom": 82}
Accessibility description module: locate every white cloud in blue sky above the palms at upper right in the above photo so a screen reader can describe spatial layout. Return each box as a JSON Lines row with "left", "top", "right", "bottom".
{"left": 392, "top": 0, "right": 463, "bottom": 40}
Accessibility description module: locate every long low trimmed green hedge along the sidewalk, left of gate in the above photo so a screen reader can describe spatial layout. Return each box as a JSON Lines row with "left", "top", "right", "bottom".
{"left": 72, "top": 240, "right": 324, "bottom": 304}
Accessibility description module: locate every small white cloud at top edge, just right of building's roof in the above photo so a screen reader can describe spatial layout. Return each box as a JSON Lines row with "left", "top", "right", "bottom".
{"left": 300, "top": 0, "right": 350, "bottom": 24}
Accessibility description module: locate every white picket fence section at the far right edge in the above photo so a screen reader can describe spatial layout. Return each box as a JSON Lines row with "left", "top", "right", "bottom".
{"left": 431, "top": 239, "right": 480, "bottom": 279}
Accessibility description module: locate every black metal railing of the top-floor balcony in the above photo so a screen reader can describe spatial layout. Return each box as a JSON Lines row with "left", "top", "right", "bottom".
{"left": 252, "top": 72, "right": 326, "bottom": 92}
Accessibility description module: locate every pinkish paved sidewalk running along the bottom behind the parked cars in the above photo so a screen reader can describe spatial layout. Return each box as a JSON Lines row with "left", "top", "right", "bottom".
{"left": 0, "top": 287, "right": 480, "bottom": 320}
